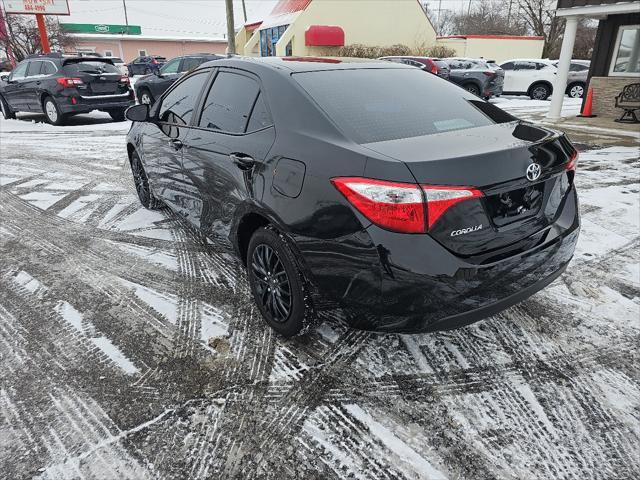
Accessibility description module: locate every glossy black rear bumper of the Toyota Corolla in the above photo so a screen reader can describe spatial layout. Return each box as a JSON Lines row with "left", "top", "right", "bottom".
{"left": 310, "top": 189, "right": 579, "bottom": 333}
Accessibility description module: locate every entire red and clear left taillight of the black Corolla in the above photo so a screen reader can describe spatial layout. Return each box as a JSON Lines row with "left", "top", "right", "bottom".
{"left": 331, "top": 177, "right": 482, "bottom": 233}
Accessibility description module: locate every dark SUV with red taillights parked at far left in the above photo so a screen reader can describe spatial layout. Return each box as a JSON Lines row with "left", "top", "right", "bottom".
{"left": 0, "top": 54, "right": 134, "bottom": 125}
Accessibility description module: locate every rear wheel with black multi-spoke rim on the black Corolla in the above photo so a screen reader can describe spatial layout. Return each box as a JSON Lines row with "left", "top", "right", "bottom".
{"left": 247, "top": 226, "right": 317, "bottom": 338}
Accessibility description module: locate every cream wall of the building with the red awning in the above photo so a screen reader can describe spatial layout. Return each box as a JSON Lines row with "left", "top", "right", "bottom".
{"left": 236, "top": 0, "right": 436, "bottom": 56}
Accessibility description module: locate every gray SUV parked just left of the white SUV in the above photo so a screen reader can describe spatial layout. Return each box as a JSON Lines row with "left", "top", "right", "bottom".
{"left": 443, "top": 57, "right": 504, "bottom": 100}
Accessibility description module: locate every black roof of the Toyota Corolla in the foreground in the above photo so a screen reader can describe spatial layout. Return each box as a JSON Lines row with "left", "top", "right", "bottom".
{"left": 200, "top": 56, "right": 404, "bottom": 73}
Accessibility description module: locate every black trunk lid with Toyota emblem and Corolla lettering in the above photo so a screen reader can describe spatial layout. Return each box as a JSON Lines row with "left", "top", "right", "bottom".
{"left": 365, "top": 122, "right": 573, "bottom": 256}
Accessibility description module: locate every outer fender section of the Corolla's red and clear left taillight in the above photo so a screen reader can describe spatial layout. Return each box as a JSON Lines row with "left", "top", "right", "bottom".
{"left": 331, "top": 177, "right": 425, "bottom": 233}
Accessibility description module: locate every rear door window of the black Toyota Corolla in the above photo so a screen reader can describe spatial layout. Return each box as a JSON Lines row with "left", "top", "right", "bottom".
{"left": 199, "top": 72, "right": 259, "bottom": 133}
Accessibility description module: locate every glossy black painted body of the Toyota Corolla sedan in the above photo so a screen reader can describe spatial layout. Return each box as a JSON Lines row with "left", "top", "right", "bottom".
{"left": 128, "top": 58, "right": 579, "bottom": 332}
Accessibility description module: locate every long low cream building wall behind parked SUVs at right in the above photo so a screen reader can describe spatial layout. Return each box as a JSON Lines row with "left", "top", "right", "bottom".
{"left": 438, "top": 37, "right": 544, "bottom": 63}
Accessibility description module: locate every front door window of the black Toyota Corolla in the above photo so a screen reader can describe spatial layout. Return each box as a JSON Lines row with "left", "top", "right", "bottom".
{"left": 158, "top": 71, "right": 209, "bottom": 125}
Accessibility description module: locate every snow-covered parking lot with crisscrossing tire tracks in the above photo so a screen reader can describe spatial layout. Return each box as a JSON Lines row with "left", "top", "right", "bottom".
{"left": 0, "top": 98, "right": 640, "bottom": 480}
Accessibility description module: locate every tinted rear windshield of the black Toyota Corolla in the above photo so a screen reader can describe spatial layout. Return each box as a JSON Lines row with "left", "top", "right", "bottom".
{"left": 293, "top": 69, "right": 504, "bottom": 143}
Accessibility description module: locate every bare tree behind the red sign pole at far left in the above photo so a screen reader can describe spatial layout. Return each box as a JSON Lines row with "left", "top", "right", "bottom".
{"left": 0, "top": 15, "right": 75, "bottom": 62}
